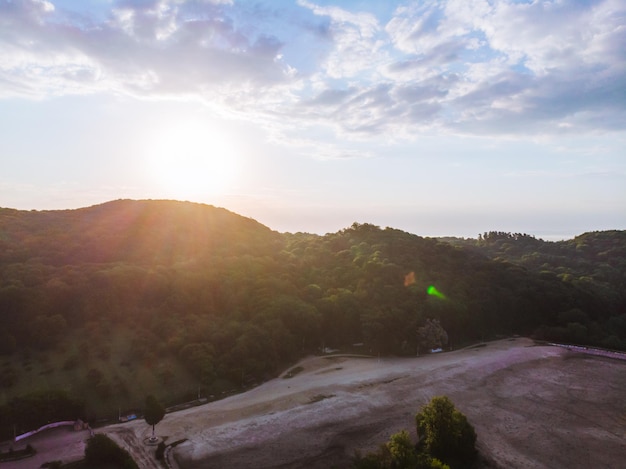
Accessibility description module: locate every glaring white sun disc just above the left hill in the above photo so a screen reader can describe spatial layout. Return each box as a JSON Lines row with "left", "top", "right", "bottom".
{"left": 147, "top": 122, "right": 237, "bottom": 200}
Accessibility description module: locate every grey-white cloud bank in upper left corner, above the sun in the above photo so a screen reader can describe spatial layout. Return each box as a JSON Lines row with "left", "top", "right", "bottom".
{"left": 0, "top": 0, "right": 290, "bottom": 95}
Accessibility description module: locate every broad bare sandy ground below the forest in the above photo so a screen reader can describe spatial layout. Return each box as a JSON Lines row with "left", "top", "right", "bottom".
{"left": 4, "top": 338, "right": 626, "bottom": 469}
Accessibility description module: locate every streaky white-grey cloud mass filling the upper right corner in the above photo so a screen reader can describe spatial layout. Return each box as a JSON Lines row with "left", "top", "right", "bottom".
{"left": 378, "top": 0, "right": 626, "bottom": 137}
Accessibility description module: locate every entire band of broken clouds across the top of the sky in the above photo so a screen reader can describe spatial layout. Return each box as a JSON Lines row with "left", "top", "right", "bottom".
{"left": 0, "top": 0, "right": 626, "bottom": 137}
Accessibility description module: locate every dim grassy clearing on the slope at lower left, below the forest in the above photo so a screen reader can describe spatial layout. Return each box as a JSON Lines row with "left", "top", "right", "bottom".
{"left": 0, "top": 329, "right": 199, "bottom": 422}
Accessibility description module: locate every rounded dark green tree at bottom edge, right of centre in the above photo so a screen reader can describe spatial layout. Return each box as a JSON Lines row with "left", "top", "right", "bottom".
{"left": 415, "top": 396, "right": 476, "bottom": 469}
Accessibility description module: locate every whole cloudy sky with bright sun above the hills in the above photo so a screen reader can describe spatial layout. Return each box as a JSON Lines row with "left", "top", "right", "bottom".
{"left": 0, "top": 0, "right": 626, "bottom": 240}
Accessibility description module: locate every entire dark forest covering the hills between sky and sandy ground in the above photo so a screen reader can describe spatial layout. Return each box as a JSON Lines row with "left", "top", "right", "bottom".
{"left": 0, "top": 200, "right": 626, "bottom": 432}
